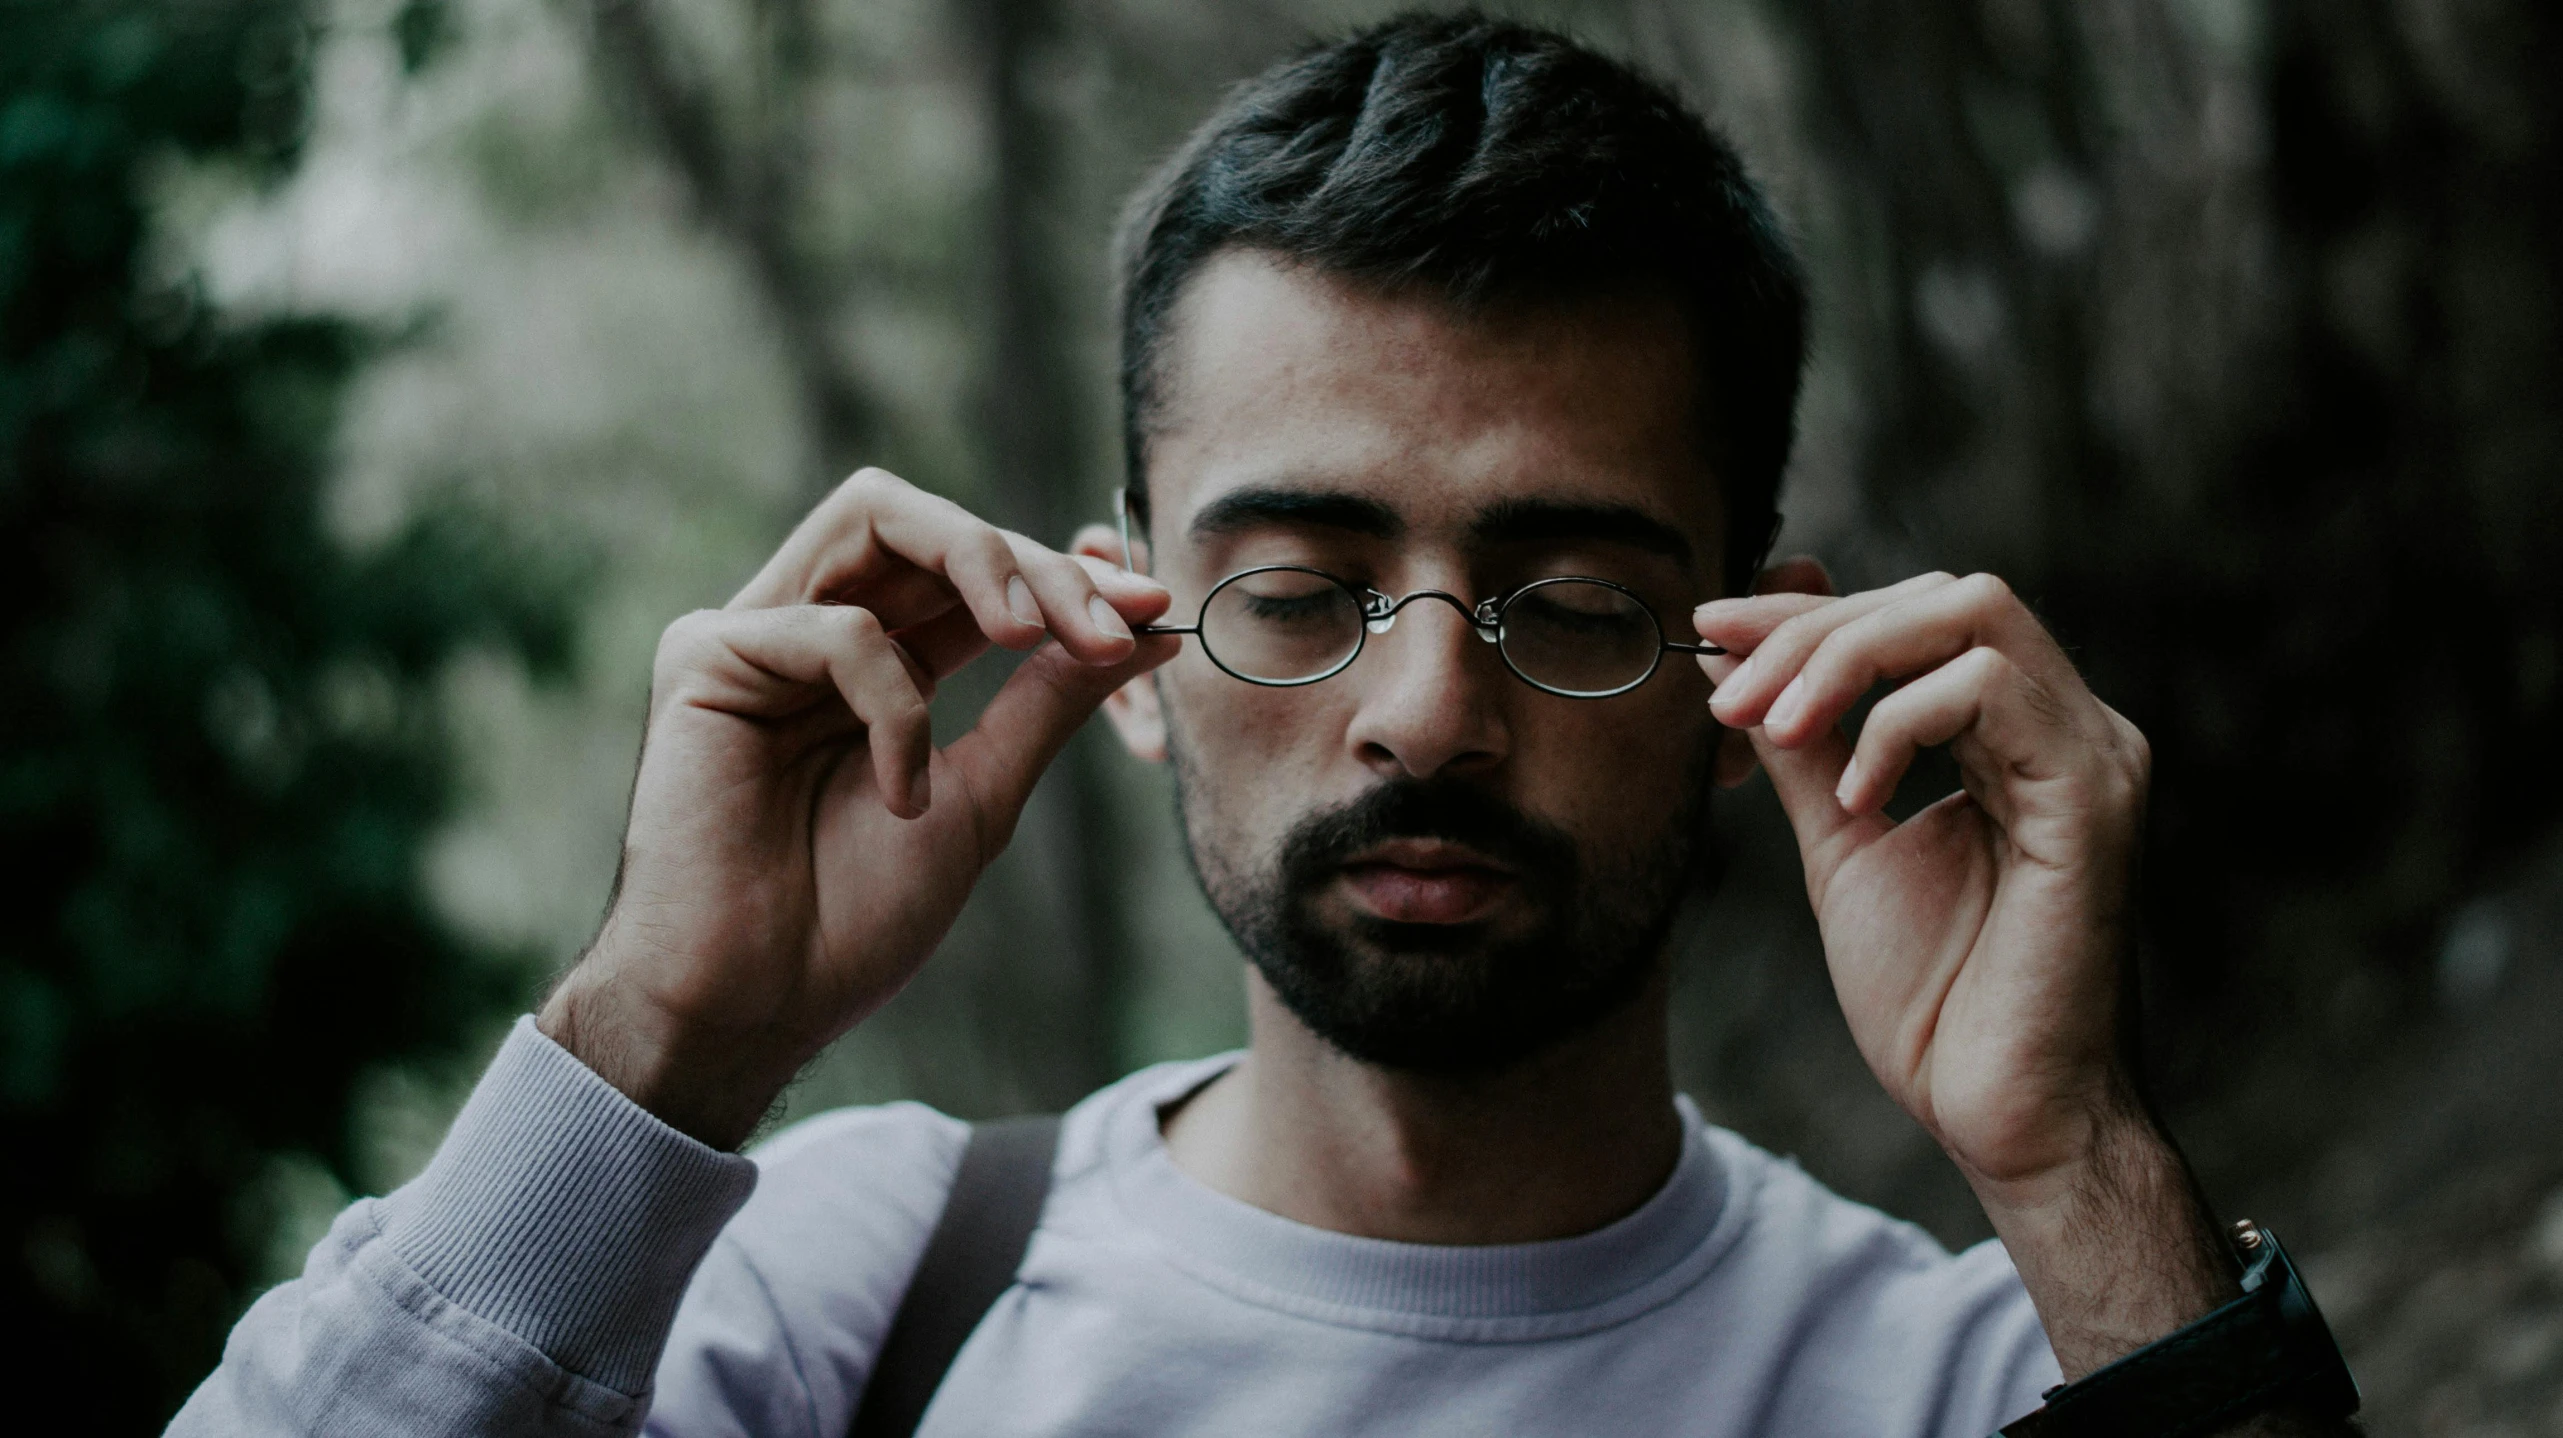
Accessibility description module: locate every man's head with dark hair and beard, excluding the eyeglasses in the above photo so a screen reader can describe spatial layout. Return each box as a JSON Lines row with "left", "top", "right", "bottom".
{"left": 1081, "top": 18, "right": 1804, "bottom": 1071}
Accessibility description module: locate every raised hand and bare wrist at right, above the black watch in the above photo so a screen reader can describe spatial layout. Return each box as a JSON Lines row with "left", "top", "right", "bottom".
{"left": 1694, "top": 561, "right": 2235, "bottom": 1376}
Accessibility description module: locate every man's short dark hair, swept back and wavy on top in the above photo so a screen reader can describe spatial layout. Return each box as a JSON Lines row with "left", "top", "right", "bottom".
{"left": 1120, "top": 13, "right": 1807, "bottom": 592}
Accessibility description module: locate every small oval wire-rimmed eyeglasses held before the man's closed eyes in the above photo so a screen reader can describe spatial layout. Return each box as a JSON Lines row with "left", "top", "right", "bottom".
{"left": 1138, "top": 564, "right": 1725, "bottom": 700}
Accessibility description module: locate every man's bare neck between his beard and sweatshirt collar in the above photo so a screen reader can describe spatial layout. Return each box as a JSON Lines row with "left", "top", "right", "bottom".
{"left": 1166, "top": 969, "right": 1681, "bottom": 1243}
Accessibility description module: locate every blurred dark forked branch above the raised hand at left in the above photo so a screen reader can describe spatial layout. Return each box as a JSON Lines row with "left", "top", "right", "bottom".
{"left": 592, "top": 0, "right": 879, "bottom": 474}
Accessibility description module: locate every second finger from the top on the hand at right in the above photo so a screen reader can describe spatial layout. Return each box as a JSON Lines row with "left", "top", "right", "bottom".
{"left": 1763, "top": 574, "right": 2084, "bottom": 746}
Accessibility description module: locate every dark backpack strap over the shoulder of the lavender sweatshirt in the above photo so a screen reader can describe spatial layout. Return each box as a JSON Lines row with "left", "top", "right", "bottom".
{"left": 848, "top": 1112, "right": 1059, "bottom": 1438}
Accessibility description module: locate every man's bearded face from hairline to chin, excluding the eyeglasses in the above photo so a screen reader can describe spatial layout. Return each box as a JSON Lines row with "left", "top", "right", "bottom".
{"left": 1115, "top": 251, "right": 1722, "bottom": 1071}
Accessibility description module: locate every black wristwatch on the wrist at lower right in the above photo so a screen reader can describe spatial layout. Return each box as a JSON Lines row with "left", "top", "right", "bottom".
{"left": 1999, "top": 1220, "right": 2358, "bottom": 1438}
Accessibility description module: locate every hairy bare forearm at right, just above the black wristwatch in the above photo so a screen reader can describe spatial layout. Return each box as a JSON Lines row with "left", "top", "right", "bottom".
{"left": 1971, "top": 1105, "right": 2358, "bottom": 1438}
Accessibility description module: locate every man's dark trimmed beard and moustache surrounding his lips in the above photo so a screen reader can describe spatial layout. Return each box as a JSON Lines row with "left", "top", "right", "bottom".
{"left": 1174, "top": 746, "right": 1707, "bottom": 1074}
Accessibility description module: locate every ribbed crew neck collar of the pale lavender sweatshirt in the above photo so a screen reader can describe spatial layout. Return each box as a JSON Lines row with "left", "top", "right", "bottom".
{"left": 1102, "top": 1054, "right": 1740, "bottom": 1341}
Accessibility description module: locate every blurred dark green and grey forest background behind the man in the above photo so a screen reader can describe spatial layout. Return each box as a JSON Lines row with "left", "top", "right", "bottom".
{"left": 0, "top": 0, "right": 2563, "bottom": 1435}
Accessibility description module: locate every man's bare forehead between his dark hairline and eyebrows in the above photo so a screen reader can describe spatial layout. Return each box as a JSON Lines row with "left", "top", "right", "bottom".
{"left": 1148, "top": 251, "right": 1720, "bottom": 564}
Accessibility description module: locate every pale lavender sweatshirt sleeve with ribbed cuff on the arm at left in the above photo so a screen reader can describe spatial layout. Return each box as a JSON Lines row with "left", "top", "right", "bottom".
{"left": 169, "top": 1018, "right": 756, "bottom": 1438}
